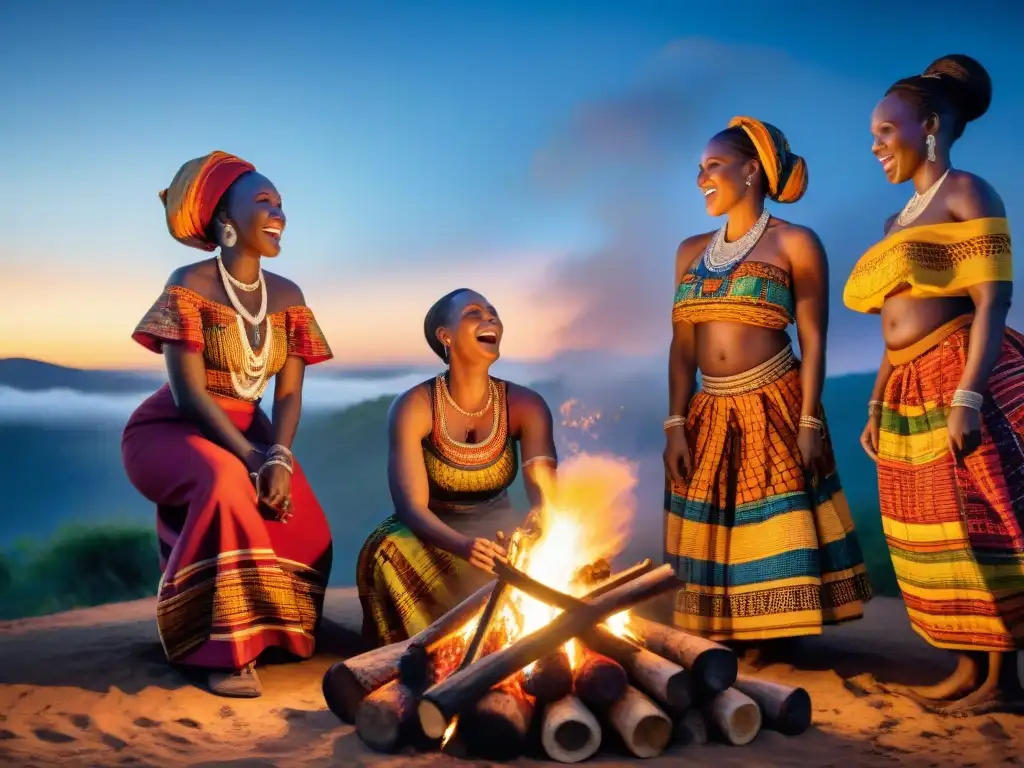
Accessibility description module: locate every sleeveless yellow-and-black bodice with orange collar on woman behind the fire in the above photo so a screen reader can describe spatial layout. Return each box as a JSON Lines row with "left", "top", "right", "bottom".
{"left": 423, "top": 377, "right": 519, "bottom": 506}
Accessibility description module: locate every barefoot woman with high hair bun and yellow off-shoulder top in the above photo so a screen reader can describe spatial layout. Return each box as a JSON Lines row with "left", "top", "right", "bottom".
{"left": 844, "top": 54, "right": 1024, "bottom": 712}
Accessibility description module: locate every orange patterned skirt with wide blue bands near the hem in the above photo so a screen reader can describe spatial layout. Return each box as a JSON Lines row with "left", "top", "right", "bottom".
{"left": 665, "top": 346, "right": 871, "bottom": 640}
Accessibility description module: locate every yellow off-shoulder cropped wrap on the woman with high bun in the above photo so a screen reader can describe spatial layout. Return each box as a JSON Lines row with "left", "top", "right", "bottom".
{"left": 843, "top": 218, "right": 1014, "bottom": 312}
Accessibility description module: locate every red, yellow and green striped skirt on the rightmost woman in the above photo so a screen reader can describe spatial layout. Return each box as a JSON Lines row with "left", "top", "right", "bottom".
{"left": 879, "top": 315, "right": 1024, "bottom": 651}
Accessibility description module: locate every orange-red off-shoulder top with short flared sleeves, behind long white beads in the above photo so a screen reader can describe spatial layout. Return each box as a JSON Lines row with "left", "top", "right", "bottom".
{"left": 132, "top": 286, "right": 334, "bottom": 400}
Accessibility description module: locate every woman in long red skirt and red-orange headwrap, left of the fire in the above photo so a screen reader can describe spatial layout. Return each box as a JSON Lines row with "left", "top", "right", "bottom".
{"left": 122, "top": 152, "right": 332, "bottom": 696}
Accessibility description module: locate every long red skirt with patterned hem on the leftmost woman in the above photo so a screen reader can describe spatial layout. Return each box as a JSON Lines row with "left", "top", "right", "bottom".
{"left": 121, "top": 385, "right": 332, "bottom": 669}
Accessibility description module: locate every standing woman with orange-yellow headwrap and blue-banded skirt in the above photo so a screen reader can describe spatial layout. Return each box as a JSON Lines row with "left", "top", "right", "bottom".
{"left": 665, "top": 118, "right": 870, "bottom": 641}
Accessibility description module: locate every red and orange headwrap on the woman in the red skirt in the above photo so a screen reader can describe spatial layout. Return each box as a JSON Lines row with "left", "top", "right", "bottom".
{"left": 160, "top": 150, "right": 256, "bottom": 251}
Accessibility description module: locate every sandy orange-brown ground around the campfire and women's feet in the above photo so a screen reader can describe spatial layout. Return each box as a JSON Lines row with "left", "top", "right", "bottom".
{"left": 0, "top": 589, "right": 1024, "bottom": 768}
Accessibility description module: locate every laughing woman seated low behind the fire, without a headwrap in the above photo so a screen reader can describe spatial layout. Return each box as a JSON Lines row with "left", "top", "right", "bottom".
{"left": 356, "top": 288, "right": 558, "bottom": 645}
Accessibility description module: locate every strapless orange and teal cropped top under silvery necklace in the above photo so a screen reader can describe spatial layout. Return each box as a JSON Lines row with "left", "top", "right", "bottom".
{"left": 672, "top": 259, "right": 796, "bottom": 330}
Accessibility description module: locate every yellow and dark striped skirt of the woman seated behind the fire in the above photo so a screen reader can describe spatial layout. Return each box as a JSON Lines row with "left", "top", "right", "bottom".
{"left": 355, "top": 493, "right": 524, "bottom": 645}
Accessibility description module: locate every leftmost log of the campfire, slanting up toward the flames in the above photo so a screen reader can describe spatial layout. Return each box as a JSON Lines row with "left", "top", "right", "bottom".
{"left": 323, "top": 584, "right": 494, "bottom": 723}
